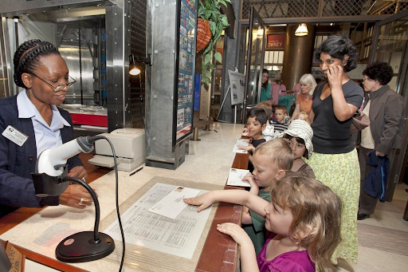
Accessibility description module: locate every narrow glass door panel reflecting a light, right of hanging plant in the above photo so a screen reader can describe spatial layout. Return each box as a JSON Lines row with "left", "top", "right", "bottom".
{"left": 242, "top": 7, "right": 266, "bottom": 124}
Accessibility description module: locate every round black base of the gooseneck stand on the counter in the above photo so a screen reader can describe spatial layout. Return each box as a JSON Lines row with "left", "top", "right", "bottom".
{"left": 55, "top": 231, "right": 115, "bottom": 263}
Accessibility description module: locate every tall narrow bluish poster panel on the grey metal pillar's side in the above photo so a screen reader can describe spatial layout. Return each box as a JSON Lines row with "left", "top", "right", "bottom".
{"left": 173, "top": 0, "right": 197, "bottom": 145}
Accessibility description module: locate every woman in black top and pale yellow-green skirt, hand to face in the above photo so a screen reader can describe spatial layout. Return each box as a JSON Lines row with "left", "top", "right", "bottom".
{"left": 308, "top": 35, "right": 363, "bottom": 262}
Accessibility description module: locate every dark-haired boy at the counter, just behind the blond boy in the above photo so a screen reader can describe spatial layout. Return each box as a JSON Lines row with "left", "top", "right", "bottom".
{"left": 238, "top": 108, "right": 268, "bottom": 172}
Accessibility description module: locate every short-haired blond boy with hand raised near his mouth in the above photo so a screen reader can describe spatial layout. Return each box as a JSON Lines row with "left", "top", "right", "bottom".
{"left": 230, "top": 139, "right": 293, "bottom": 253}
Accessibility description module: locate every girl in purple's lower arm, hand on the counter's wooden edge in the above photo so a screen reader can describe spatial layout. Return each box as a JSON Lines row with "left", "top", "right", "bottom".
{"left": 217, "top": 223, "right": 259, "bottom": 272}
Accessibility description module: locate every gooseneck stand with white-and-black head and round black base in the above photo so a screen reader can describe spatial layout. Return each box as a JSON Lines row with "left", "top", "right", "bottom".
{"left": 31, "top": 135, "right": 116, "bottom": 263}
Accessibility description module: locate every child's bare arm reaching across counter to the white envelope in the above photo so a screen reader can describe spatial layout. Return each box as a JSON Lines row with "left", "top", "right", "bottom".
{"left": 184, "top": 190, "right": 269, "bottom": 216}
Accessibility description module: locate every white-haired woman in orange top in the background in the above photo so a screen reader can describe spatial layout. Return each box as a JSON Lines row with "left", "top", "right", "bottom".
{"left": 290, "top": 74, "right": 317, "bottom": 122}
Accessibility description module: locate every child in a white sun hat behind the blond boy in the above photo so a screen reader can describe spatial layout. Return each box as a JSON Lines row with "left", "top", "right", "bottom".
{"left": 281, "top": 119, "right": 316, "bottom": 178}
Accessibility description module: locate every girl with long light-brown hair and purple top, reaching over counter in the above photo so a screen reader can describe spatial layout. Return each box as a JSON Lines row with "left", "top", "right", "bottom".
{"left": 184, "top": 173, "right": 341, "bottom": 272}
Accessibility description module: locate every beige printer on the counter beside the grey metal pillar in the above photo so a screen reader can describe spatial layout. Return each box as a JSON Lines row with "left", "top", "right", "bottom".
{"left": 88, "top": 128, "right": 146, "bottom": 171}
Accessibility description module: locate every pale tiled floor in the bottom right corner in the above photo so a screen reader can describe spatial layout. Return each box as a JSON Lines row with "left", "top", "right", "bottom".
{"left": 343, "top": 184, "right": 408, "bottom": 272}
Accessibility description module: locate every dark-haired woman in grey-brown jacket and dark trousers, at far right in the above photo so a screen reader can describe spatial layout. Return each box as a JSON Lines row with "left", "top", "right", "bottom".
{"left": 357, "top": 62, "right": 404, "bottom": 220}
